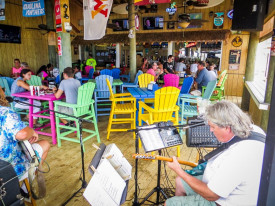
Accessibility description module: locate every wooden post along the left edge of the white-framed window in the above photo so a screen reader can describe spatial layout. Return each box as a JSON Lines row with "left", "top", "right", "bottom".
{"left": 241, "top": 32, "right": 259, "bottom": 111}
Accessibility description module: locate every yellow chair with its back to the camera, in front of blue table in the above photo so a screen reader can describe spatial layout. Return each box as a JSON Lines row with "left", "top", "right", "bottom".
{"left": 138, "top": 87, "right": 180, "bottom": 157}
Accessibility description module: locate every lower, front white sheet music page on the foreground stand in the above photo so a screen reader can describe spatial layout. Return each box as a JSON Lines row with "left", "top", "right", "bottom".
{"left": 83, "top": 159, "right": 126, "bottom": 206}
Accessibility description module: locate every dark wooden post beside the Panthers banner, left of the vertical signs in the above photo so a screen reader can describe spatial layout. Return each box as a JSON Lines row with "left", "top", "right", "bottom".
{"left": 45, "top": 1, "right": 57, "bottom": 66}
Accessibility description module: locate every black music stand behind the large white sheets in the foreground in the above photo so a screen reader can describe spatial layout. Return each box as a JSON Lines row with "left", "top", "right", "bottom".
{"left": 88, "top": 143, "right": 129, "bottom": 205}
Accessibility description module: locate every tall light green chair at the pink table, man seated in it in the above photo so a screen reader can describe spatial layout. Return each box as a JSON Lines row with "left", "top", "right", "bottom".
{"left": 54, "top": 82, "right": 100, "bottom": 149}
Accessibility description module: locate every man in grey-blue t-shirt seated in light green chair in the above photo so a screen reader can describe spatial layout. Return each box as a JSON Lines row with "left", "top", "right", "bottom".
{"left": 53, "top": 67, "right": 81, "bottom": 133}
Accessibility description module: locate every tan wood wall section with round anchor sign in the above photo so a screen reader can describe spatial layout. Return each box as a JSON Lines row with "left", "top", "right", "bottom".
{"left": 221, "top": 33, "right": 249, "bottom": 97}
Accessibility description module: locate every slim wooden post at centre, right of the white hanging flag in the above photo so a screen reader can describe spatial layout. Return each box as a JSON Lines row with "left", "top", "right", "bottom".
{"left": 128, "top": 0, "right": 137, "bottom": 82}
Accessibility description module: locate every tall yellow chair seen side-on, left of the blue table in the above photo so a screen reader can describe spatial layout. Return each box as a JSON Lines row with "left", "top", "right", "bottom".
{"left": 106, "top": 79, "right": 136, "bottom": 140}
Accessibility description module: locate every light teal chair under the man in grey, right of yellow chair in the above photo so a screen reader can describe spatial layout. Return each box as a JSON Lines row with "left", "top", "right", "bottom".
{"left": 179, "top": 80, "right": 217, "bottom": 130}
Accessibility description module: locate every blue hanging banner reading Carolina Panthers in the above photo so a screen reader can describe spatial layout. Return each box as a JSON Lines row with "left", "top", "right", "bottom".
{"left": 22, "top": 0, "right": 45, "bottom": 17}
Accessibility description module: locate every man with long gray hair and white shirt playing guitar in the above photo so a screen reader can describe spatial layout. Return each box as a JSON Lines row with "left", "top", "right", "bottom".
{"left": 165, "top": 101, "right": 265, "bottom": 206}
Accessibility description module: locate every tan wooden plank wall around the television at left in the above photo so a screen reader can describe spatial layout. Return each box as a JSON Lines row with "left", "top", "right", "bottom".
{"left": 0, "top": 1, "right": 49, "bottom": 76}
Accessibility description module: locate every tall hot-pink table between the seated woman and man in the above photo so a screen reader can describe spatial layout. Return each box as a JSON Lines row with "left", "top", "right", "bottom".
{"left": 12, "top": 92, "right": 65, "bottom": 144}
